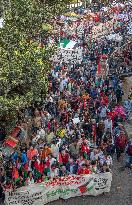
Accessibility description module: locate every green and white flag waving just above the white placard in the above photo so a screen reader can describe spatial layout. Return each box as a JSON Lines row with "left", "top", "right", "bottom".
{"left": 58, "top": 38, "right": 77, "bottom": 50}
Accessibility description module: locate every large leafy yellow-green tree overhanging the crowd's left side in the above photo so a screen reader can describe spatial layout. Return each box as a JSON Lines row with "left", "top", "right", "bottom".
{"left": 0, "top": 0, "right": 72, "bottom": 128}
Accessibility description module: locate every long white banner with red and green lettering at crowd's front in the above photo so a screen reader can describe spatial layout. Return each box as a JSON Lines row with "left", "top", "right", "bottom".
{"left": 5, "top": 173, "right": 112, "bottom": 205}
